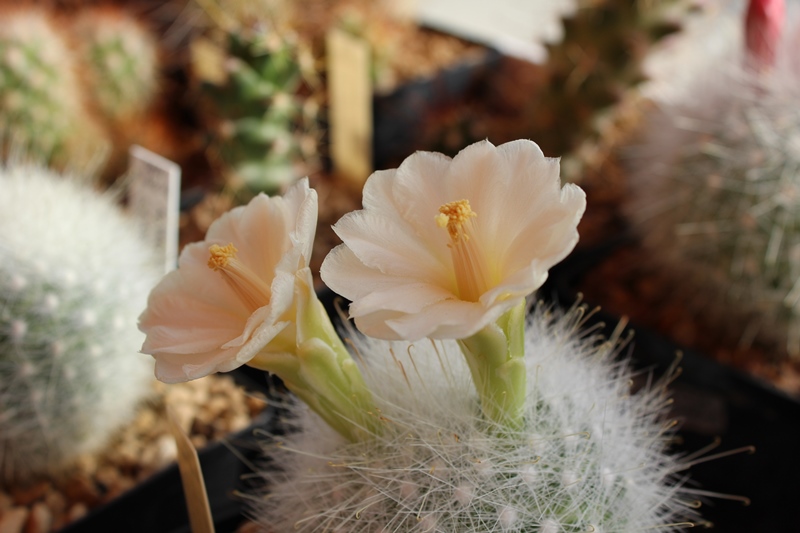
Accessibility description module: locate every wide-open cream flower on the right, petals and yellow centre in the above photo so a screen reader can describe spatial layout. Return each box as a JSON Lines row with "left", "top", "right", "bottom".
{"left": 322, "top": 140, "right": 586, "bottom": 340}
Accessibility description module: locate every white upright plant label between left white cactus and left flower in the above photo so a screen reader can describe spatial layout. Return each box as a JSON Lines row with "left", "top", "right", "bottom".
{"left": 128, "top": 145, "right": 181, "bottom": 273}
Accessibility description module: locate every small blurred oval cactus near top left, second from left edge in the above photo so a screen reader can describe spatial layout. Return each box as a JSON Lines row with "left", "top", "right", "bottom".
{"left": 73, "top": 8, "right": 159, "bottom": 122}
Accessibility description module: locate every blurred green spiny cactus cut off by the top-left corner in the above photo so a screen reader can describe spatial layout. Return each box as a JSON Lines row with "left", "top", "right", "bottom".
{"left": 0, "top": 9, "right": 105, "bottom": 169}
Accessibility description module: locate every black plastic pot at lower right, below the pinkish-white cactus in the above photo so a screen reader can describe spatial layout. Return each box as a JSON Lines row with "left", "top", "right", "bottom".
{"left": 540, "top": 243, "right": 800, "bottom": 533}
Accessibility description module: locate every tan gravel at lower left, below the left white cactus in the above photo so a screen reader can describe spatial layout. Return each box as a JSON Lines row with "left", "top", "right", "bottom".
{"left": 0, "top": 376, "right": 266, "bottom": 533}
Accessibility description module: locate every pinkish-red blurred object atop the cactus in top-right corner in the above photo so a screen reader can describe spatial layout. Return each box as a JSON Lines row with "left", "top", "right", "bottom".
{"left": 745, "top": 0, "right": 786, "bottom": 69}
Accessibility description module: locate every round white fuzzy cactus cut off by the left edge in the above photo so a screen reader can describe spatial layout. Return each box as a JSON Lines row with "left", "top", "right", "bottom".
{"left": 0, "top": 165, "right": 158, "bottom": 482}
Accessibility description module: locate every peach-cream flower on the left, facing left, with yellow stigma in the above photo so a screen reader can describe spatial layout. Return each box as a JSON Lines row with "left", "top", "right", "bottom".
{"left": 139, "top": 179, "right": 317, "bottom": 383}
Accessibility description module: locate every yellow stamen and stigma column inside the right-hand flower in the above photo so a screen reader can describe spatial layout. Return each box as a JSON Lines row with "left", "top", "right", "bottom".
{"left": 435, "top": 200, "right": 489, "bottom": 302}
